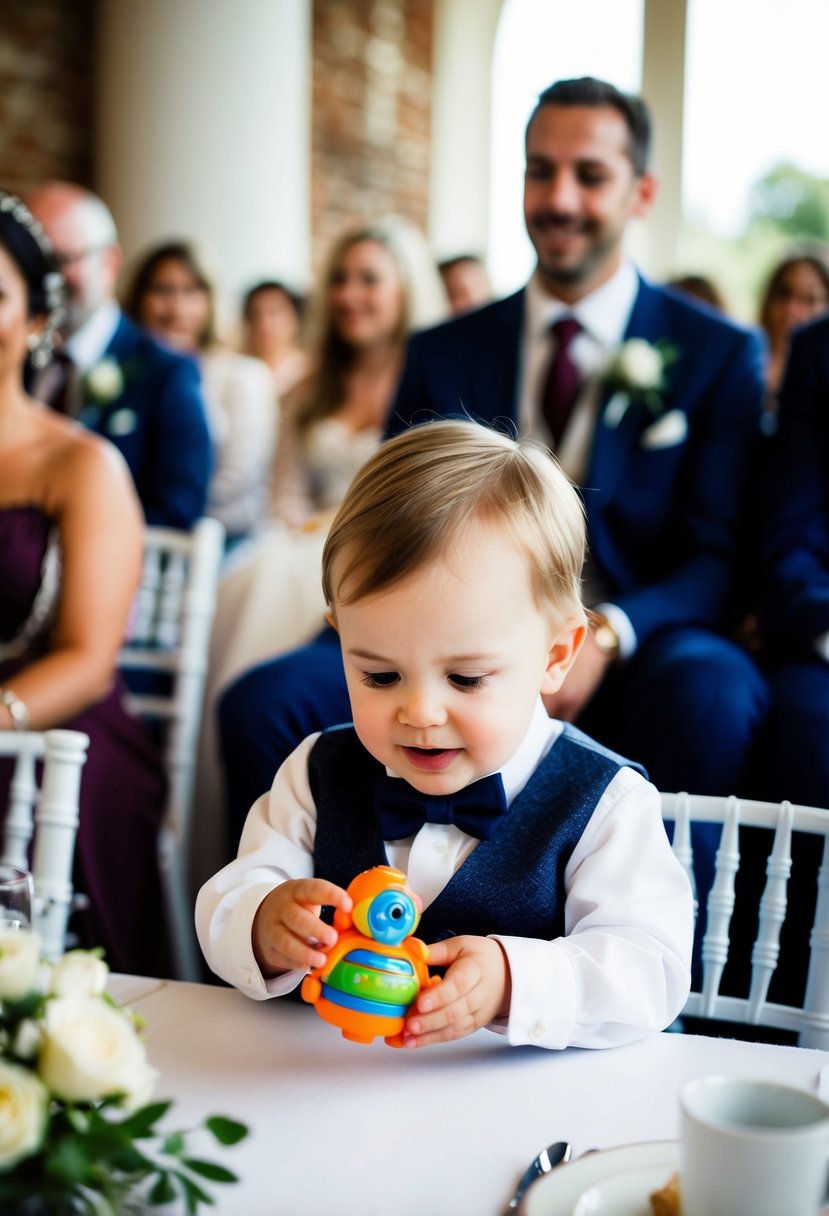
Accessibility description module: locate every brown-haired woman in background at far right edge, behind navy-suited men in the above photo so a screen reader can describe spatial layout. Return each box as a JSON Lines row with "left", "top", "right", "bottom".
{"left": 760, "top": 253, "right": 829, "bottom": 434}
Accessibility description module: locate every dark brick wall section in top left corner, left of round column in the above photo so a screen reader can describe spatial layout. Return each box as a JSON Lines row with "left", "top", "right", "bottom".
{"left": 0, "top": 0, "right": 98, "bottom": 193}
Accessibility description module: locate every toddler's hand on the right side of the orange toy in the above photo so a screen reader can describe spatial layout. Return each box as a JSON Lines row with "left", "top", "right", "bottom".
{"left": 404, "top": 938, "right": 511, "bottom": 1047}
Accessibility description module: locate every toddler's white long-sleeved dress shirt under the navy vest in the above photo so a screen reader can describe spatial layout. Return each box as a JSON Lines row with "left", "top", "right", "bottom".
{"left": 196, "top": 699, "right": 693, "bottom": 1048}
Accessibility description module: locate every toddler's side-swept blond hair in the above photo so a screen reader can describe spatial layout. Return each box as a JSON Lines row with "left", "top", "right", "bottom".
{"left": 322, "top": 421, "right": 586, "bottom": 619}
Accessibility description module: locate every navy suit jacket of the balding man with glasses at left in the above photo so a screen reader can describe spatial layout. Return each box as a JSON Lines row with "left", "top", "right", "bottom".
{"left": 79, "top": 314, "right": 213, "bottom": 529}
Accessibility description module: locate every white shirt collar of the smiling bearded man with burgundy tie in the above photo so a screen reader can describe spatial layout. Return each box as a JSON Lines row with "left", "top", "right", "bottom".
{"left": 526, "top": 260, "right": 639, "bottom": 350}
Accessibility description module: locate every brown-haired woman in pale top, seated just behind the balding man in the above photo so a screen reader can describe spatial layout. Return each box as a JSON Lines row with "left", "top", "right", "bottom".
{"left": 124, "top": 241, "right": 276, "bottom": 547}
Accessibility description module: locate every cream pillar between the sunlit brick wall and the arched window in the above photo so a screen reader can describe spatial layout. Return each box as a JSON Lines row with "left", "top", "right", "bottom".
{"left": 429, "top": 0, "right": 503, "bottom": 258}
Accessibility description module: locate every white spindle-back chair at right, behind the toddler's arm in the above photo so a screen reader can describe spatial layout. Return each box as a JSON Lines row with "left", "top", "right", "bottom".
{"left": 661, "top": 793, "right": 829, "bottom": 1051}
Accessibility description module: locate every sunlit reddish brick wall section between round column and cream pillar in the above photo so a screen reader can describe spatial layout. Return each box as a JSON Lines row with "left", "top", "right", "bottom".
{"left": 311, "top": 0, "right": 434, "bottom": 268}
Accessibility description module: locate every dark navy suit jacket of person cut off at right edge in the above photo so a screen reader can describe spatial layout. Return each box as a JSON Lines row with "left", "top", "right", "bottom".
{"left": 761, "top": 317, "right": 829, "bottom": 657}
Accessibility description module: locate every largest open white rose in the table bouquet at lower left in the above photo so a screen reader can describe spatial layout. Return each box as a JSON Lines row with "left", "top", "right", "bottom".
{"left": 38, "top": 996, "right": 158, "bottom": 1102}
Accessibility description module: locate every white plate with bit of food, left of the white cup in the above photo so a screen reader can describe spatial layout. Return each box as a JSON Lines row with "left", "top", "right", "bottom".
{"left": 520, "top": 1141, "right": 679, "bottom": 1216}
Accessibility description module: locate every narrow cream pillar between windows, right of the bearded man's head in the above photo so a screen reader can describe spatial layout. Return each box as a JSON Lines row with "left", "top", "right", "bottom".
{"left": 637, "top": 0, "right": 687, "bottom": 278}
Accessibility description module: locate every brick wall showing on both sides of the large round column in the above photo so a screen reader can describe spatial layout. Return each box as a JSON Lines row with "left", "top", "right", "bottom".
{"left": 0, "top": 0, "right": 434, "bottom": 268}
